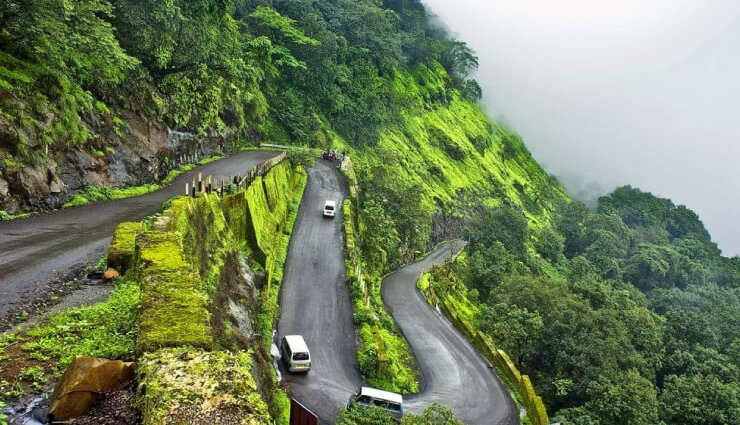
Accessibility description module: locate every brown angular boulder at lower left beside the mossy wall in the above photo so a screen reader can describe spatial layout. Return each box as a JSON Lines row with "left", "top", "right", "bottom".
{"left": 49, "top": 356, "right": 136, "bottom": 421}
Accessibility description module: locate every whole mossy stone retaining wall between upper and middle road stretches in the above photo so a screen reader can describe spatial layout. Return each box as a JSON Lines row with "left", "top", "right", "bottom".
{"left": 136, "top": 159, "right": 305, "bottom": 425}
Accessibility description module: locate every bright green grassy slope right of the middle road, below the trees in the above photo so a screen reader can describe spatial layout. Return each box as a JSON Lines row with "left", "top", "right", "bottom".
{"left": 334, "top": 64, "right": 570, "bottom": 271}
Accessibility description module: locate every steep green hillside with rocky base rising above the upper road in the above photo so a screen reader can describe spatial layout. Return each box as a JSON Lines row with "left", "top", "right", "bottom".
{"left": 0, "top": 0, "right": 564, "bottom": 229}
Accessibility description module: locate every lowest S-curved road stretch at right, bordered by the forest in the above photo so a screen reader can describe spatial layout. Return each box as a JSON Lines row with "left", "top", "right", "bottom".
{"left": 382, "top": 242, "right": 519, "bottom": 425}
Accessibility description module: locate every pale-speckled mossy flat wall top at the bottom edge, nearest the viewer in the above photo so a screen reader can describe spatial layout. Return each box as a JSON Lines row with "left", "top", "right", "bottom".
{"left": 137, "top": 348, "right": 272, "bottom": 425}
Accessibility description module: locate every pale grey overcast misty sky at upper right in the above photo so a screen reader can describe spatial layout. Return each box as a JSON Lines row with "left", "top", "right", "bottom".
{"left": 423, "top": 0, "right": 740, "bottom": 255}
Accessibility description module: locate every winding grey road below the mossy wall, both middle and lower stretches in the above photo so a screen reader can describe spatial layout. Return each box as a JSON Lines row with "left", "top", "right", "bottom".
{"left": 277, "top": 161, "right": 518, "bottom": 425}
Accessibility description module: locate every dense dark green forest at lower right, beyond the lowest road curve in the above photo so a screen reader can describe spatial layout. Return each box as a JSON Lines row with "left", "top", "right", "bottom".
{"left": 434, "top": 187, "right": 740, "bottom": 425}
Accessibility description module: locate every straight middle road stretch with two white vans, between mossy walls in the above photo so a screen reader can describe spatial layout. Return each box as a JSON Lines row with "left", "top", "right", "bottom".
{"left": 278, "top": 161, "right": 362, "bottom": 423}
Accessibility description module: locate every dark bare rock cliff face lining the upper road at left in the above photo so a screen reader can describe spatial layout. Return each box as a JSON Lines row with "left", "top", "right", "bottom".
{"left": 0, "top": 111, "right": 236, "bottom": 214}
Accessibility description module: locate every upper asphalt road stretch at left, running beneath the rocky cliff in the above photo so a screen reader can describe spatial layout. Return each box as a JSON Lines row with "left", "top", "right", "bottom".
{"left": 0, "top": 151, "right": 277, "bottom": 317}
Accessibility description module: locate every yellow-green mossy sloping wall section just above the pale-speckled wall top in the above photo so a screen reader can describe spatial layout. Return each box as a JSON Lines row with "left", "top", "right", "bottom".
{"left": 136, "top": 232, "right": 213, "bottom": 353}
